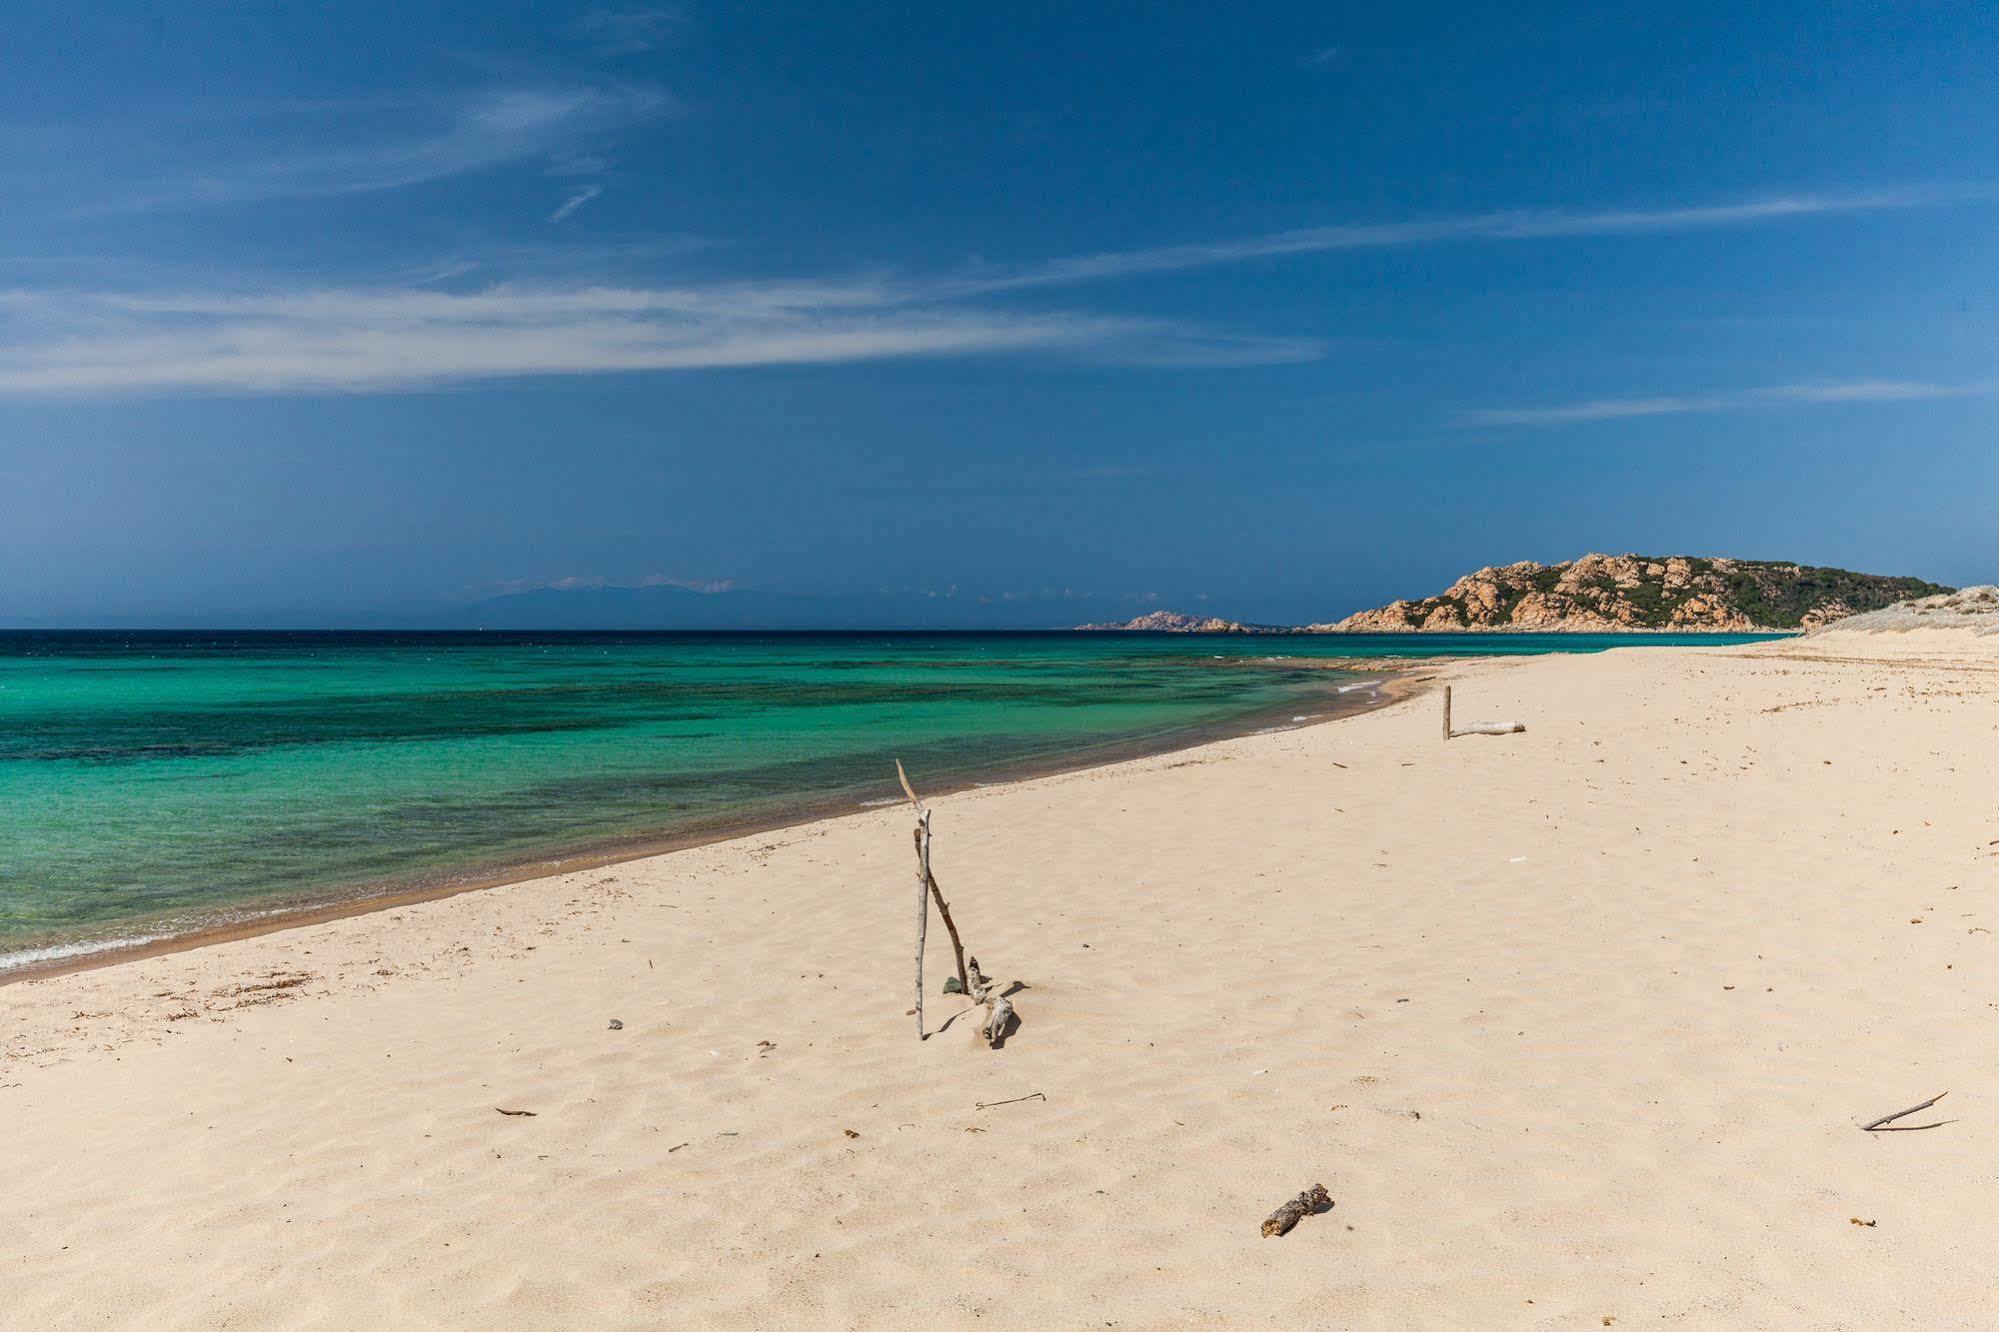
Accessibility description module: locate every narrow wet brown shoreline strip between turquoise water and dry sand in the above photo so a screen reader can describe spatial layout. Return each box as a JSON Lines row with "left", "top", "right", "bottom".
{"left": 0, "top": 658, "right": 1423, "bottom": 990}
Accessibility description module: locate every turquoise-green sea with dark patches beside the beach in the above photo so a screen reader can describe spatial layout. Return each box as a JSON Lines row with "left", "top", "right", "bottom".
{"left": 0, "top": 632, "right": 1783, "bottom": 968}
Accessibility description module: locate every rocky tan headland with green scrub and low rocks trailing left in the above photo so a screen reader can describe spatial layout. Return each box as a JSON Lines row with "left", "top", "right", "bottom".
{"left": 1079, "top": 554, "right": 1951, "bottom": 634}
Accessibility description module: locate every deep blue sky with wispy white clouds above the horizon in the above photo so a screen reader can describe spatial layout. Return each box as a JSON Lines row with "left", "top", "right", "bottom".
{"left": 0, "top": 0, "right": 1999, "bottom": 626}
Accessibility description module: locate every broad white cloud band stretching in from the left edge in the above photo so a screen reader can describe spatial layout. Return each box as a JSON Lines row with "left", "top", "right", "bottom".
{"left": 0, "top": 284, "right": 1215, "bottom": 394}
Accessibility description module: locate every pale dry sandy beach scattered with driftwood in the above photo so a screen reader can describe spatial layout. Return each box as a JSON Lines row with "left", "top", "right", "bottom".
{"left": 0, "top": 630, "right": 1999, "bottom": 1328}
